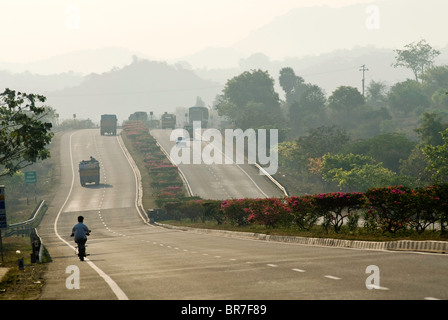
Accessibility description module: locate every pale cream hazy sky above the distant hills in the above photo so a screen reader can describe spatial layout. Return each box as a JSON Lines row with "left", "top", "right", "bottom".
{"left": 0, "top": 0, "right": 381, "bottom": 62}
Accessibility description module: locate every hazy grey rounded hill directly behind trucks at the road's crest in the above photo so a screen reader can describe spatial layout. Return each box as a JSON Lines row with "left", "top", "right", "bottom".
{"left": 47, "top": 57, "right": 223, "bottom": 122}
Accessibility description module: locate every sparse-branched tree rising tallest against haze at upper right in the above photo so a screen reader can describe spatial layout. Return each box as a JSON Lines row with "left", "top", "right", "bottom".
{"left": 393, "top": 40, "right": 440, "bottom": 81}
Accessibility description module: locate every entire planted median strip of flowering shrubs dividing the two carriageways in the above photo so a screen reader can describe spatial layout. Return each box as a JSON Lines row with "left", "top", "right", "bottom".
{"left": 119, "top": 121, "right": 448, "bottom": 240}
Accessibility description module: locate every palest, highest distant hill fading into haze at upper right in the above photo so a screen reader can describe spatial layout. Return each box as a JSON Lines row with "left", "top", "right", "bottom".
{"left": 232, "top": 0, "right": 448, "bottom": 60}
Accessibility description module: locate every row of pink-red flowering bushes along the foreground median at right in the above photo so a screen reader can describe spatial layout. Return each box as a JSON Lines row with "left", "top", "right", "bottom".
{"left": 174, "top": 185, "right": 448, "bottom": 234}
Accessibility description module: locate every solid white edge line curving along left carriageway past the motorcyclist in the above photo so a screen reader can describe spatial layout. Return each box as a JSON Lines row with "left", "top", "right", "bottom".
{"left": 53, "top": 131, "right": 129, "bottom": 300}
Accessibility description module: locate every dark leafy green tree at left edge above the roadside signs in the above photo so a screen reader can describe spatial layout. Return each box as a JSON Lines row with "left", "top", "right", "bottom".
{"left": 0, "top": 89, "right": 53, "bottom": 177}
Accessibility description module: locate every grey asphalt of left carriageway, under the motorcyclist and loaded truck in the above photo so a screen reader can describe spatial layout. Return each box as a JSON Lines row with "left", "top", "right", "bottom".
{"left": 38, "top": 130, "right": 448, "bottom": 302}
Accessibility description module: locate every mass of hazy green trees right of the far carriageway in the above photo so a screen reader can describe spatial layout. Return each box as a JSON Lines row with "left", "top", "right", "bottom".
{"left": 214, "top": 40, "right": 448, "bottom": 193}
